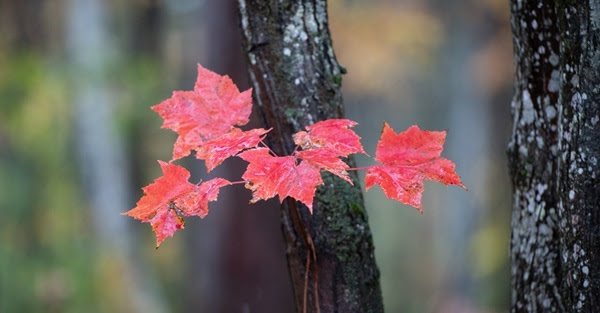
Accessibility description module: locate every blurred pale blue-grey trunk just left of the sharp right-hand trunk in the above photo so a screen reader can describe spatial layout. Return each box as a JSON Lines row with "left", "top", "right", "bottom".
{"left": 420, "top": 0, "right": 492, "bottom": 312}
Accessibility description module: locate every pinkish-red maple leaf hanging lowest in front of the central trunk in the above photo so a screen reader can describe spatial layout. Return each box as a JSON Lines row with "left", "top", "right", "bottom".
{"left": 239, "top": 148, "right": 323, "bottom": 213}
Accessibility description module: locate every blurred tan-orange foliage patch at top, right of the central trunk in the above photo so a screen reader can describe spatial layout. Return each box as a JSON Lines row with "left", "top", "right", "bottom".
{"left": 329, "top": 1, "right": 443, "bottom": 97}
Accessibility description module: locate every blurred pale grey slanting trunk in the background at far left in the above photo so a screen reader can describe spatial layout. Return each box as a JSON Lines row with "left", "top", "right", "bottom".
{"left": 65, "top": 0, "right": 167, "bottom": 313}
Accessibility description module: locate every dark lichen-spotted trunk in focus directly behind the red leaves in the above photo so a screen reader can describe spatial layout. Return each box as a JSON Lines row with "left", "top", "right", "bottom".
{"left": 238, "top": 0, "right": 383, "bottom": 312}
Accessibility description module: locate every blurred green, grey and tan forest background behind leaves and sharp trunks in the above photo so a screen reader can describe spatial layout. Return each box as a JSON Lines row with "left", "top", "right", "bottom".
{"left": 0, "top": 0, "right": 513, "bottom": 313}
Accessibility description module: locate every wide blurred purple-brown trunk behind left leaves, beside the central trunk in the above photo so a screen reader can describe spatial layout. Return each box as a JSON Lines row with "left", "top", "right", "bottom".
{"left": 163, "top": 0, "right": 293, "bottom": 313}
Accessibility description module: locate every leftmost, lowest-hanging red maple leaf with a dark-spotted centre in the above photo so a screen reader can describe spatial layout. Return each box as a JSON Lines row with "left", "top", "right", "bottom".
{"left": 123, "top": 161, "right": 230, "bottom": 248}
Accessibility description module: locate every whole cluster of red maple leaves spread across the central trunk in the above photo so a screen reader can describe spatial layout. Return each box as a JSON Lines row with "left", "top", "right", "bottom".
{"left": 124, "top": 65, "right": 464, "bottom": 248}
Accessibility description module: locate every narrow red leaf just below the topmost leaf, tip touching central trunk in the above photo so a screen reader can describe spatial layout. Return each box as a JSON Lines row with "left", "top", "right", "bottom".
{"left": 196, "top": 128, "right": 270, "bottom": 172}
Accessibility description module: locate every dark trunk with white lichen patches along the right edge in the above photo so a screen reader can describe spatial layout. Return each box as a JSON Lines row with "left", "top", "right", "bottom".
{"left": 508, "top": 0, "right": 600, "bottom": 313}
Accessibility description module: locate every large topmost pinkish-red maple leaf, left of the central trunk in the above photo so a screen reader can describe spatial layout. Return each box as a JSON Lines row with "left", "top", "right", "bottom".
{"left": 152, "top": 65, "right": 252, "bottom": 159}
